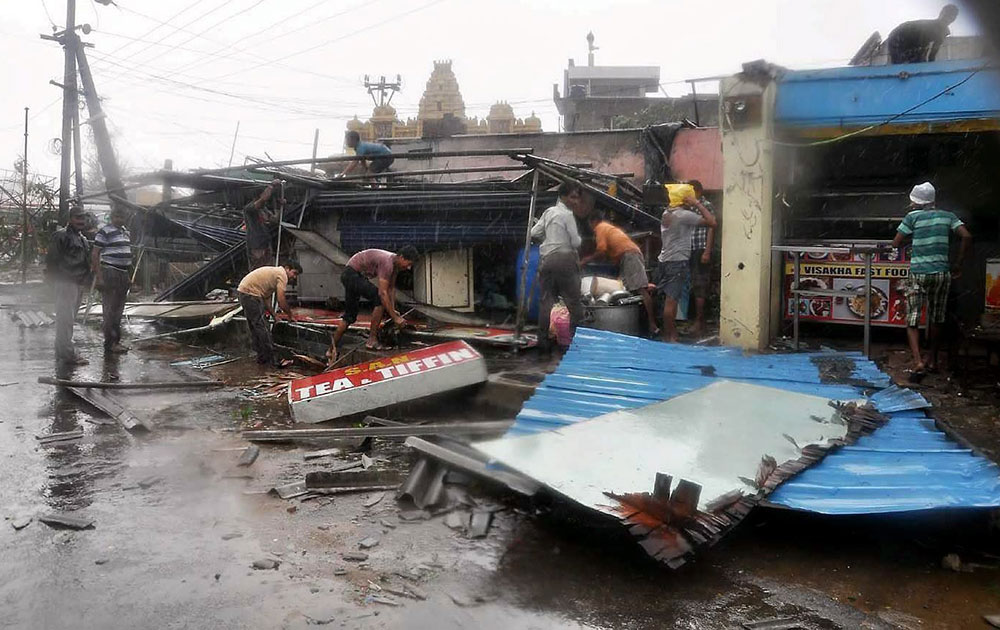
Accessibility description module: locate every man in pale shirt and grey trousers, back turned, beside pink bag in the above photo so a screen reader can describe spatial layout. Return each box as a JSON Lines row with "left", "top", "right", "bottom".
{"left": 531, "top": 182, "right": 594, "bottom": 354}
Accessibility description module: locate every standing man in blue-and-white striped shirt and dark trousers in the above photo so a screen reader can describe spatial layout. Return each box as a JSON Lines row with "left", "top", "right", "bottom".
{"left": 91, "top": 205, "right": 132, "bottom": 353}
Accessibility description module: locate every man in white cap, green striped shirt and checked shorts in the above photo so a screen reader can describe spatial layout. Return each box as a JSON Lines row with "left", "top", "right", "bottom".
{"left": 892, "top": 182, "right": 972, "bottom": 374}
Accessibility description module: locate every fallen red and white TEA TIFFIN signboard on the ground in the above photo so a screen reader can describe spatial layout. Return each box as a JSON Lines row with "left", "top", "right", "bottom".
{"left": 288, "top": 341, "right": 487, "bottom": 422}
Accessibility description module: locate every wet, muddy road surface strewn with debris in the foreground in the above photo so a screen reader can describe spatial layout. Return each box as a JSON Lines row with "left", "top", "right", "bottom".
{"left": 0, "top": 294, "right": 1000, "bottom": 629}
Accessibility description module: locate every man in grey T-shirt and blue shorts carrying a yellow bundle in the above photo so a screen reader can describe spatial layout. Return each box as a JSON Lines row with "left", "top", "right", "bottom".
{"left": 657, "top": 196, "right": 718, "bottom": 341}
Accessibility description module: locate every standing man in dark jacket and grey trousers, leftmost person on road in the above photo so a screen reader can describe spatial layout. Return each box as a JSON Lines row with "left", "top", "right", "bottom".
{"left": 45, "top": 201, "right": 90, "bottom": 365}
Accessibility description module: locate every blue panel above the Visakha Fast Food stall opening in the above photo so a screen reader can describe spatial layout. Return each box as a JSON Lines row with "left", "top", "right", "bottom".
{"left": 775, "top": 59, "right": 1000, "bottom": 127}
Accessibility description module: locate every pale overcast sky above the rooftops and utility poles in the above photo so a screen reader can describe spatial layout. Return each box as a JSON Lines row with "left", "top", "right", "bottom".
{"left": 0, "top": 0, "right": 978, "bottom": 181}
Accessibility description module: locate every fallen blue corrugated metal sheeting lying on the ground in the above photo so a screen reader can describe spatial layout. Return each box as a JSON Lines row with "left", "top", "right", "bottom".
{"left": 510, "top": 328, "right": 1000, "bottom": 514}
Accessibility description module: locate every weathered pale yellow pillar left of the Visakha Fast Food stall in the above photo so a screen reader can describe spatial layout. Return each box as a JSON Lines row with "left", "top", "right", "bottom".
{"left": 719, "top": 77, "right": 780, "bottom": 350}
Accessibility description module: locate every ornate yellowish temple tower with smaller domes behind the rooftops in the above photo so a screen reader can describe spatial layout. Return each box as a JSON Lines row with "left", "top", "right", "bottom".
{"left": 347, "top": 60, "right": 542, "bottom": 141}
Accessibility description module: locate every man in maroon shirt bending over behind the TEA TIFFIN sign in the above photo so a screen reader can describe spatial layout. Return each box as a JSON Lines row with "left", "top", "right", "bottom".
{"left": 327, "top": 245, "right": 418, "bottom": 364}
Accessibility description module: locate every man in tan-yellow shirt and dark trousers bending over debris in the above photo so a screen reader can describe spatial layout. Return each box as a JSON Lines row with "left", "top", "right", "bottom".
{"left": 236, "top": 261, "right": 302, "bottom": 368}
